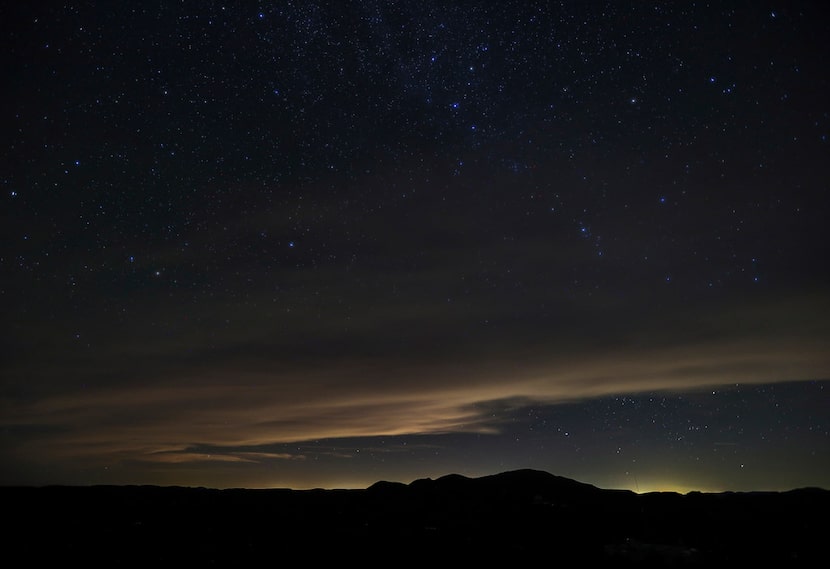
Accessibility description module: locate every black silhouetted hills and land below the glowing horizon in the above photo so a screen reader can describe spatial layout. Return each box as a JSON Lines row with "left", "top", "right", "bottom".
{"left": 0, "top": 470, "right": 830, "bottom": 567}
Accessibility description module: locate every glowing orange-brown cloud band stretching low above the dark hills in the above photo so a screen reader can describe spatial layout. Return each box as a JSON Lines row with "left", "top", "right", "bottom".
{"left": 3, "top": 310, "right": 830, "bottom": 474}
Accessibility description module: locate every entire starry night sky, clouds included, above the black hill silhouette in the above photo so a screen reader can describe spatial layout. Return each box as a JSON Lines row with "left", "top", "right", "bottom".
{"left": 0, "top": 0, "right": 830, "bottom": 491}
